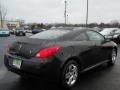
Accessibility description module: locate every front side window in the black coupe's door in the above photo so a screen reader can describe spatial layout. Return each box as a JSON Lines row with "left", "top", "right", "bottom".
{"left": 86, "top": 31, "right": 104, "bottom": 41}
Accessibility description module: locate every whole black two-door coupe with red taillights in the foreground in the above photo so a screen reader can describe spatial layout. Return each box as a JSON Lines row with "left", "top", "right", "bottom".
{"left": 4, "top": 29, "right": 117, "bottom": 88}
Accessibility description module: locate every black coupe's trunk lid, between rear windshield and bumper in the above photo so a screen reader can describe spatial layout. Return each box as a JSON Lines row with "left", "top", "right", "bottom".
{"left": 9, "top": 39, "right": 54, "bottom": 58}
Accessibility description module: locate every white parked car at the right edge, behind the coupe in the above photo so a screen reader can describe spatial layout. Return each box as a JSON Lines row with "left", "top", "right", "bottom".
{"left": 100, "top": 28, "right": 120, "bottom": 44}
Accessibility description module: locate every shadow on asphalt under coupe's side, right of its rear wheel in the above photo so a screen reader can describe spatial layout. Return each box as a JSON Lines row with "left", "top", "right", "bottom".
{"left": 73, "top": 64, "right": 115, "bottom": 90}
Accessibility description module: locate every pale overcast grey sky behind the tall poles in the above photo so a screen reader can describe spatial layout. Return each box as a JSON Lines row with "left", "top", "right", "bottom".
{"left": 1, "top": 0, "right": 120, "bottom": 23}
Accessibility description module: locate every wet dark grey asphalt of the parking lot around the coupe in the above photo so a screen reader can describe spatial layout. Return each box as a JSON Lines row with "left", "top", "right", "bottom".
{"left": 0, "top": 34, "right": 120, "bottom": 90}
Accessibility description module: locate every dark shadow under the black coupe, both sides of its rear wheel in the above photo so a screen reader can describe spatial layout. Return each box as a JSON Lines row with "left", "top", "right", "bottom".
{"left": 6, "top": 63, "right": 113, "bottom": 90}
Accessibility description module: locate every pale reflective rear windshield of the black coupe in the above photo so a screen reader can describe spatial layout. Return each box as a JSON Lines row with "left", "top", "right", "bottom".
{"left": 30, "top": 30, "right": 70, "bottom": 40}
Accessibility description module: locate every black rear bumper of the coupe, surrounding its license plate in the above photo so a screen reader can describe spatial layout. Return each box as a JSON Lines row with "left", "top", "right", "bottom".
{"left": 4, "top": 54, "right": 60, "bottom": 79}
